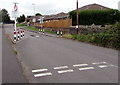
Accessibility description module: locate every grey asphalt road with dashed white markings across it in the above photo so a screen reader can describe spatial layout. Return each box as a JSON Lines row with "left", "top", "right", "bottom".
{"left": 6, "top": 25, "right": 119, "bottom": 83}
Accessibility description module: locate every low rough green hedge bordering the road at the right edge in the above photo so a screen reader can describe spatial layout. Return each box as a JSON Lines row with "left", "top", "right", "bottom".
{"left": 72, "top": 22, "right": 120, "bottom": 49}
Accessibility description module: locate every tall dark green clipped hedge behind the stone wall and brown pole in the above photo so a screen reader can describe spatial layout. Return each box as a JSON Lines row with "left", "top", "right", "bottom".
{"left": 69, "top": 9, "right": 120, "bottom": 25}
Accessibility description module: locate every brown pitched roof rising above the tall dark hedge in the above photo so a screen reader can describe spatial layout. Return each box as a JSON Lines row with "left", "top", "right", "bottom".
{"left": 79, "top": 3, "right": 110, "bottom": 10}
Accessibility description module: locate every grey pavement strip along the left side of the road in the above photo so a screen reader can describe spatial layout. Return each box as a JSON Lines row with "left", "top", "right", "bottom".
{"left": 2, "top": 25, "right": 27, "bottom": 83}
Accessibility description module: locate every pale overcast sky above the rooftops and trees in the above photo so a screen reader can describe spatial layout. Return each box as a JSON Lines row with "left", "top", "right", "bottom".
{"left": 0, "top": 0, "right": 120, "bottom": 16}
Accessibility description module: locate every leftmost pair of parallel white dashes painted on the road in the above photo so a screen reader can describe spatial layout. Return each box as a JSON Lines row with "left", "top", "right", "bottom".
{"left": 32, "top": 69, "right": 52, "bottom": 77}
